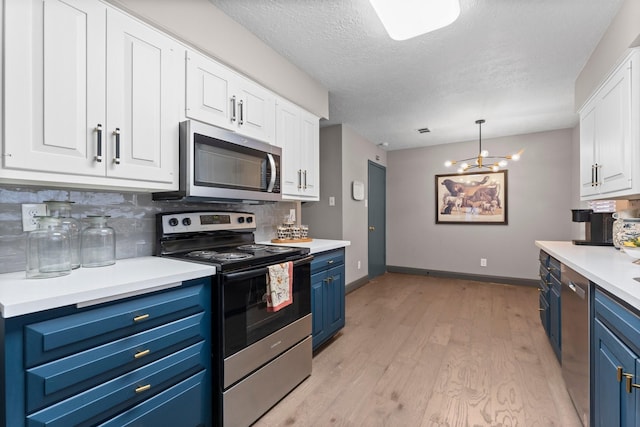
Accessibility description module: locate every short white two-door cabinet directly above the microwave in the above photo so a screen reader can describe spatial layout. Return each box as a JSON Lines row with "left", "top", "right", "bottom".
{"left": 185, "top": 51, "right": 275, "bottom": 144}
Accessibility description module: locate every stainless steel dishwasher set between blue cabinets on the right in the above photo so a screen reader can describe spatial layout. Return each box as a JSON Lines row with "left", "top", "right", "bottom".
{"left": 560, "top": 264, "right": 590, "bottom": 427}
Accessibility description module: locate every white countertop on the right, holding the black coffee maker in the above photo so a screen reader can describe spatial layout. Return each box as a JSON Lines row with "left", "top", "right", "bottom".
{"left": 536, "top": 241, "right": 640, "bottom": 310}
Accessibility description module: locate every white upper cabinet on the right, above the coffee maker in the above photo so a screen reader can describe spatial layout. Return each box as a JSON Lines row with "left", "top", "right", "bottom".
{"left": 580, "top": 50, "right": 640, "bottom": 200}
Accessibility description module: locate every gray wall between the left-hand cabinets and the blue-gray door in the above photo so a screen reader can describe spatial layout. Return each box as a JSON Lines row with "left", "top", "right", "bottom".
{"left": 302, "top": 125, "right": 387, "bottom": 284}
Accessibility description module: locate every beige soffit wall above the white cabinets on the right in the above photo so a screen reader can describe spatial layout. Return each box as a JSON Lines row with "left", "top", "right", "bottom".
{"left": 575, "top": 0, "right": 640, "bottom": 109}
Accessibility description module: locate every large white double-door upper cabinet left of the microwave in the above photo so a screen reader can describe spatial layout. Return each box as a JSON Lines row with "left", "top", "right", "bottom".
{"left": 0, "top": 0, "right": 184, "bottom": 190}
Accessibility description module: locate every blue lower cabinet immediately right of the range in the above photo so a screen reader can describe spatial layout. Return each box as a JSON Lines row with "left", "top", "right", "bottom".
{"left": 311, "top": 249, "right": 345, "bottom": 350}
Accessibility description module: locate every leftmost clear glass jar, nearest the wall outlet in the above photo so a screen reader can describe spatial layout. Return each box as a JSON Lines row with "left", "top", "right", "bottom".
{"left": 26, "top": 216, "right": 71, "bottom": 279}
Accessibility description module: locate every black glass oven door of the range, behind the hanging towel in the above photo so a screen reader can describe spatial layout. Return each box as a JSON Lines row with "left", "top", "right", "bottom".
{"left": 221, "top": 256, "right": 313, "bottom": 359}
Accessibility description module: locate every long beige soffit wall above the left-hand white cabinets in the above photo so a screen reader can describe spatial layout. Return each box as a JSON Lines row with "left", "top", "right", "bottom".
{"left": 108, "top": 0, "right": 329, "bottom": 118}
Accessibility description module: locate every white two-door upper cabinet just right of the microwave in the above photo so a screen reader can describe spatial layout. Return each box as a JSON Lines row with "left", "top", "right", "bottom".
{"left": 276, "top": 100, "right": 320, "bottom": 201}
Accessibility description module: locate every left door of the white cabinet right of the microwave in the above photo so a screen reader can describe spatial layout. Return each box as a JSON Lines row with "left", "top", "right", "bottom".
{"left": 276, "top": 101, "right": 302, "bottom": 196}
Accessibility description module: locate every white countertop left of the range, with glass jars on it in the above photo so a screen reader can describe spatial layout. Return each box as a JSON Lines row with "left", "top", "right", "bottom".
{"left": 0, "top": 256, "right": 216, "bottom": 318}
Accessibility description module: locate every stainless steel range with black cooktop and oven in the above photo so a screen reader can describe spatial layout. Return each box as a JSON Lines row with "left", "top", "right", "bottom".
{"left": 156, "top": 211, "right": 313, "bottom": 427}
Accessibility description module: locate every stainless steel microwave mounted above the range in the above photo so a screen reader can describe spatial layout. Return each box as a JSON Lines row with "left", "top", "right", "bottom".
{"left": 153, "top": 120, "right": 282, "bottom": 203}
